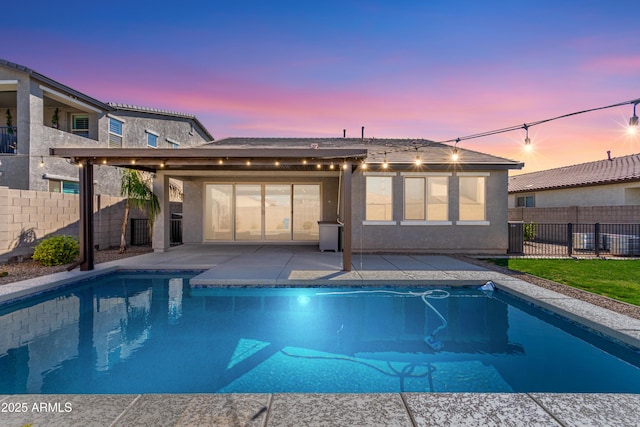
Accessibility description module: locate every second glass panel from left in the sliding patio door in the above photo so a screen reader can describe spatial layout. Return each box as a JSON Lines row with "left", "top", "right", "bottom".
{"left": 236, "top": 184, "right": 262, "bottom": 240}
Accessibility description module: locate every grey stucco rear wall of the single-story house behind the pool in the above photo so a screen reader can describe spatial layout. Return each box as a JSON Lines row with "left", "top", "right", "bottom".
{"left": 183, "top": 171, "right": 508, "bottom": 254}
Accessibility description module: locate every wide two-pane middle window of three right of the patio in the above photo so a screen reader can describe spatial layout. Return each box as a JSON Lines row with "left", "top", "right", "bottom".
{"left": 404, "top": 176, "right": 449, "bottom": 221}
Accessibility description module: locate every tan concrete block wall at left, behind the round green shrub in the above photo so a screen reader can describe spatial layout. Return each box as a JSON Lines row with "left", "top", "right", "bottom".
{"left": 0, "top": 187, "right": 151, "bottom": 262}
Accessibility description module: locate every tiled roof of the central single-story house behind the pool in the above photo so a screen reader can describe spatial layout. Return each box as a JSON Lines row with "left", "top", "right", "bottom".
{"left": 206, "top": 138, "right": 523, "bottom": 169}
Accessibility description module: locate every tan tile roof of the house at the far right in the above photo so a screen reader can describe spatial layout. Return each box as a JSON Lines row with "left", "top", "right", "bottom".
{"left": 509, "top": 154, "right": 640, "bottom": 193}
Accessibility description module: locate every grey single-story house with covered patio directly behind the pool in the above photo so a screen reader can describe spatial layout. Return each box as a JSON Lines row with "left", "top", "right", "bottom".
{"left": 53, "top": 138, "right": 523, "bottom": 270}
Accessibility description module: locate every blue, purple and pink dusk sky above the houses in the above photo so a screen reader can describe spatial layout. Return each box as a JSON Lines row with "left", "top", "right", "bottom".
{"left": 0, "top": 0, "right": 640, "bottom": 172}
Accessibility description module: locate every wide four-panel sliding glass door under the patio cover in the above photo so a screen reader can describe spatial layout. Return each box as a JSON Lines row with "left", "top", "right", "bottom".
{"left": 204, "top": 183, "right": 321, "bottom": 242}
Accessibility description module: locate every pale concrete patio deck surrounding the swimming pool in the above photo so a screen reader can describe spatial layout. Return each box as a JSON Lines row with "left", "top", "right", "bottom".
{"left": 0, "top": 245, "right": 640, "bottom": 426}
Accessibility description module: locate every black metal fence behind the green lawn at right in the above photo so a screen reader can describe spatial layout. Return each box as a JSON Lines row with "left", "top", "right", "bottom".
{"left": 508, "top": 223, "right": 640, "bottom": 257}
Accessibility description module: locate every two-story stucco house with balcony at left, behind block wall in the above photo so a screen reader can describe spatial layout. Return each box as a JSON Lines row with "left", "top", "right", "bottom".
{"left": 0, "top": 59, "right": 213, "bottom": 195}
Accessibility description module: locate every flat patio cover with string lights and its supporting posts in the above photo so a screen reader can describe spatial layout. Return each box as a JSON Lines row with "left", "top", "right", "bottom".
{"left": 49, "top": 147, "right": 367, "bottom": 271}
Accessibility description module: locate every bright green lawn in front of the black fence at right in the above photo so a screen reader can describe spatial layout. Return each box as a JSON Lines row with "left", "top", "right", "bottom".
{"left": 490, "top": 258, "right": 640, "bottom": 306}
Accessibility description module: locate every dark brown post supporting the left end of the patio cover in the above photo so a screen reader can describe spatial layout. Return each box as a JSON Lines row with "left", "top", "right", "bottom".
{"left": 78, "top": 160, "right": 94, "bottom": 271}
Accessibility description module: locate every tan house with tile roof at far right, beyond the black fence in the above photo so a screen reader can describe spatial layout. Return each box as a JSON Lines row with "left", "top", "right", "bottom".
{"left": 509, "top": 154, "right": 640, "bottom": 223}
